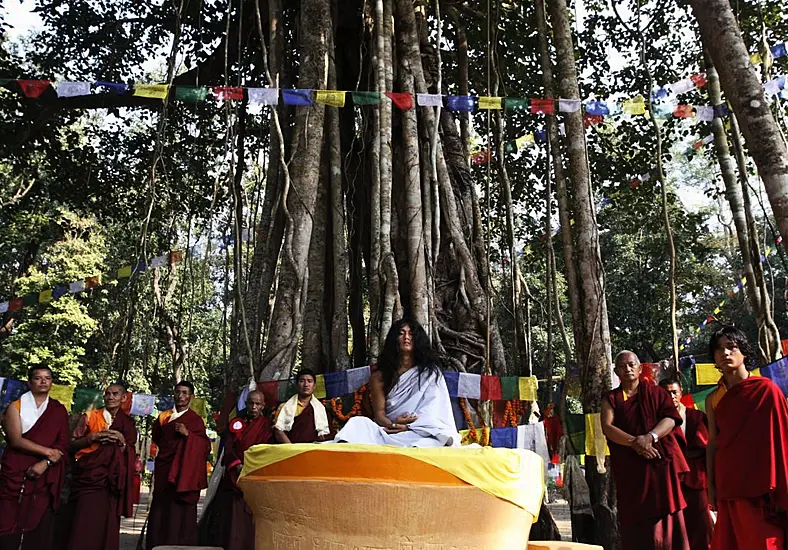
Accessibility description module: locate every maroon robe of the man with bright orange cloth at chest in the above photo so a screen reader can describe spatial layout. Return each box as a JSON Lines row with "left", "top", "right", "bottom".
{"left": 68, "top": 409, "right": 137, "bottom": 550}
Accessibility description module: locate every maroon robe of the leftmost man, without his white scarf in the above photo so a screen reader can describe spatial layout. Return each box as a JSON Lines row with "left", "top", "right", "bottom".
{"left": 0, "top": 399, "right": 69, "bottom": 550}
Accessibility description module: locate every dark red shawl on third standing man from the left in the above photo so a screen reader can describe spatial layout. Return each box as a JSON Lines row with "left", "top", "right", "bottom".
{"left": 152, "top": 409, "right": 211, "bottom": 504}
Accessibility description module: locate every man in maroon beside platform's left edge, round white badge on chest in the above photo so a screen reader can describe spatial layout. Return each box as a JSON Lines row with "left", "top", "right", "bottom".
{"left": 200, "top": 391, "right": 271, "bottom": 550}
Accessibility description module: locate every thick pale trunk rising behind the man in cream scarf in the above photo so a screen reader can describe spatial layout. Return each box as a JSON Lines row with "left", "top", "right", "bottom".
{"left": 262, "top": 0, "right": 331, "bottom": 380}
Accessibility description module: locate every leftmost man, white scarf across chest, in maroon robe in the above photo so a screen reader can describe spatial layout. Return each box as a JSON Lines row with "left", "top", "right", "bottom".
{"left": 0, "top": 367, "right": 68, "bottom": 550}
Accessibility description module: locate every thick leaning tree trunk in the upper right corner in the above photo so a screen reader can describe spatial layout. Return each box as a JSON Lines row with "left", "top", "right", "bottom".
{"left": 690, "top": 0, "right": 788, "bottom": 248}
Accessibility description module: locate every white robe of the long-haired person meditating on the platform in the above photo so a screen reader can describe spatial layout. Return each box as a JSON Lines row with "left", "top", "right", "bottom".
{"left": 334, "top": 367, "right": 461, "bottom": 447}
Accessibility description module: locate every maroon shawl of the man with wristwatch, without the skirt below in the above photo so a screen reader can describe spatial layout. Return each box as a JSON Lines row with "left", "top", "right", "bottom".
{"left": 608, "top": 382, "right": 689, "bottom": 526}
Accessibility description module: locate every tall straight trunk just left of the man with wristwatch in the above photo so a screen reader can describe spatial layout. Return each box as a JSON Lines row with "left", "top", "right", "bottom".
{"left": 547, "top": 0, "right": 618, "bottom": 550}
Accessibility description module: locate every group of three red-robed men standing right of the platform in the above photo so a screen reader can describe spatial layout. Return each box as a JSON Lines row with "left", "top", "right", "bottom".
{"left": 601, "top": 326, "right": 788, "bottom": 550}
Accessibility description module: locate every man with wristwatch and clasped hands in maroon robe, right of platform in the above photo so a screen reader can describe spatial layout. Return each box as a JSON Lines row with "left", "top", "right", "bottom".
{"left": 601, "top": 351, "right": 689, "bottom": 550}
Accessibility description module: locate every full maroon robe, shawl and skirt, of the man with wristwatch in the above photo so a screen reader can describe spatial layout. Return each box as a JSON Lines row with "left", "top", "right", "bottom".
{"left": 607, "top": 381, "right": 689, "bottom": 550}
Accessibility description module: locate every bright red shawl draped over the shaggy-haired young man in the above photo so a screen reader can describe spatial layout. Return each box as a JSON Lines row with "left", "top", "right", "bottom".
{"left": 714, "top": 376, "right": 788, "bottom": 509}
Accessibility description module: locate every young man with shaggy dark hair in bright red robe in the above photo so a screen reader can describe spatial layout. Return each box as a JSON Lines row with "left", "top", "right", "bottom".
{"left": 706, "top": 326, "right": 788, "bottom": 550}
